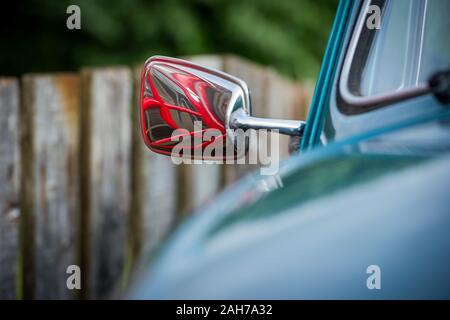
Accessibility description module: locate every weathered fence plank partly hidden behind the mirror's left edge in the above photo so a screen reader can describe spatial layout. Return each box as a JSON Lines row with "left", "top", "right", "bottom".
{"left": 130, "top": 69, "right": 177, "bottom": 258}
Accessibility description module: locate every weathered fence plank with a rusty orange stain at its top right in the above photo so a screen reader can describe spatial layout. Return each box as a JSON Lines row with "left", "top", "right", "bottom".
{"left": 21, "top": 74, "right": 79, "bottom": 299}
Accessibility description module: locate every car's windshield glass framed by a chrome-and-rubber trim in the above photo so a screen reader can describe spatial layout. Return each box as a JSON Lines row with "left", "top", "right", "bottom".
{"left": 349, "top": 0, "right": 450, "bottom": 96}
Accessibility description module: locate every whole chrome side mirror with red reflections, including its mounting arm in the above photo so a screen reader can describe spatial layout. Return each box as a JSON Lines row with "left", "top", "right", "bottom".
{"left": 140, "top": 56, "right": 304, "bottom": 160}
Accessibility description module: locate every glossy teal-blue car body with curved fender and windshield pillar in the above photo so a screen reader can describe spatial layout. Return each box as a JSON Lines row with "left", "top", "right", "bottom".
{"left": 130, "top": 0, "right": 450, "bottom": 299}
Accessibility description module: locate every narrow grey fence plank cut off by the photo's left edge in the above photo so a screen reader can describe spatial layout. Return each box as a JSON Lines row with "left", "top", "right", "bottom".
{"left": 0, "top": 78, "right": 20, "bottom": 300}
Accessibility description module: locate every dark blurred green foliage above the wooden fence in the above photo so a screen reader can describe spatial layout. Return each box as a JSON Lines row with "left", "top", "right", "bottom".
{"left": 0, "top": 0, "right": 337, "bottom": 78}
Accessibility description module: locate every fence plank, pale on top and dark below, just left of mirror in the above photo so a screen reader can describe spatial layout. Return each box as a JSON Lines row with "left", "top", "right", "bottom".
{"left": 81, "top": 68, "right": 132, "bottom": 298}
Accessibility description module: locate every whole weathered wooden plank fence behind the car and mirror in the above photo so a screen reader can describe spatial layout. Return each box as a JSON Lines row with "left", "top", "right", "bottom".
{"left": 0, "top": 56, "right": 312, "bottom": 299}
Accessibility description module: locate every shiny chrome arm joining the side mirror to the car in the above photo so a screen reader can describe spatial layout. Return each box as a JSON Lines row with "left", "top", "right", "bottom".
{"left": 230, "top": 109, "right": 306, "bottom": 137}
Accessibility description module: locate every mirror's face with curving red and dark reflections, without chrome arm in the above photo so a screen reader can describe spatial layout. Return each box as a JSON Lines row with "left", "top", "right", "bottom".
{"left": 140, "top": 59, "right": 231, "bottom": 159}
